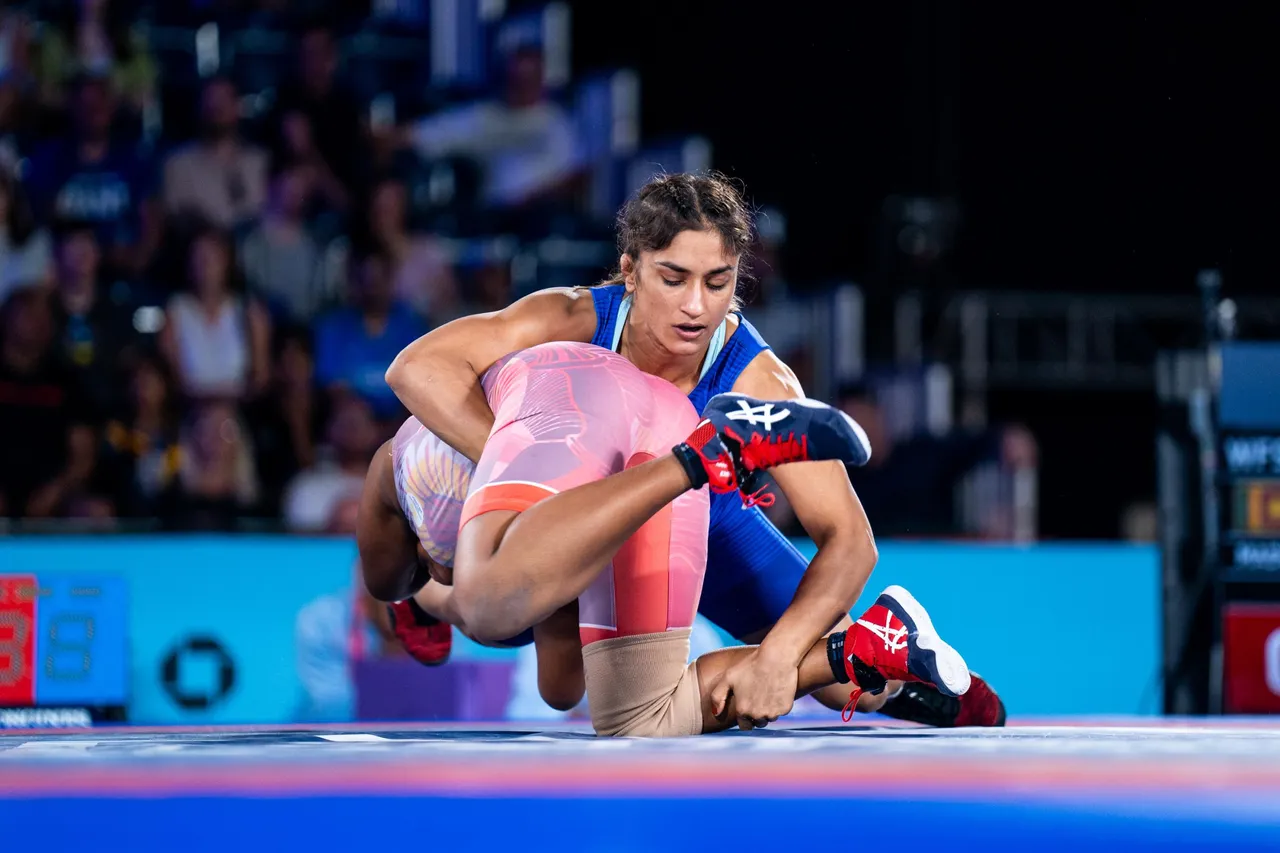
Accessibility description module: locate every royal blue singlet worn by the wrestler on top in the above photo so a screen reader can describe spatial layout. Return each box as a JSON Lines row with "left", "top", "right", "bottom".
{"left": 591, "top": 284, "right": 809, "bottom": 639}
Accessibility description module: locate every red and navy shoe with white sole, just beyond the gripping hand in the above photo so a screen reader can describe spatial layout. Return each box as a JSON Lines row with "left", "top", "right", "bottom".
{"left": 827, "top": 585, "right": 970, "bottom": 722}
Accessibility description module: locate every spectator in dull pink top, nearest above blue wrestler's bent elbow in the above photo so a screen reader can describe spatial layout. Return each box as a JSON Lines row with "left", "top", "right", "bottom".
{"left": 356, "top": 177, "right": 458, "bottom": 321}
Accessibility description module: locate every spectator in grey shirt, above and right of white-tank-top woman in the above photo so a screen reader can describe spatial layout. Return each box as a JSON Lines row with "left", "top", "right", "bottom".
{"left": 241, "top": 165, "right": 346, "bottom": 324}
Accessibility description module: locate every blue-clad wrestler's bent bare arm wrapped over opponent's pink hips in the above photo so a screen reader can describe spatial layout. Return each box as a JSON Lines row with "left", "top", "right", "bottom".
{"left": 387, "top": 288, "right": 595, "bottom": 462}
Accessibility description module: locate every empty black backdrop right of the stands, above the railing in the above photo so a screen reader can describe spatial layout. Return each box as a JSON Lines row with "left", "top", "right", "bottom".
{"left": 572, "top": 0, "right": 1280, "bottom": 538}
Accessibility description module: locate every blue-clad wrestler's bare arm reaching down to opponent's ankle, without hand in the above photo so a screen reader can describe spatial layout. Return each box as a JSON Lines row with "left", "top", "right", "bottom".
{"left": 733, "top": 350, "right": 877, "bottom": 665}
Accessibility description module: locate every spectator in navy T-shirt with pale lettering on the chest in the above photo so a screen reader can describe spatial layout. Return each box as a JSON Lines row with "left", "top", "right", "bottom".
{"left": 27, "top": 77, "right": 163, "bottom": 275}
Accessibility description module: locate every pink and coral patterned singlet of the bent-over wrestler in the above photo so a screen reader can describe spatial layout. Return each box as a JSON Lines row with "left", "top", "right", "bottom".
{"left": 393, "top": 342, "right": 709, "bottom": 646}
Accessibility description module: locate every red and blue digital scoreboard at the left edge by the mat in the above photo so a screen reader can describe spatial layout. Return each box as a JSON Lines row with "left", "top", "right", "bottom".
{"left": 0, "top": 574, "right": 129, "bottom": 729}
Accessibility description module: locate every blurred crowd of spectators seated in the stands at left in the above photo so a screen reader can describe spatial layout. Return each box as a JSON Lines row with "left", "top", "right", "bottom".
{"left": 0, "top": 0, "right": 588, "bottom": 530}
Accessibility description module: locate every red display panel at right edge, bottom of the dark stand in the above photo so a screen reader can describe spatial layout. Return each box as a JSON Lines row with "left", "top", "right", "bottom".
{"left": 1222, "top": 603, "right": 1280, "bottom": 713}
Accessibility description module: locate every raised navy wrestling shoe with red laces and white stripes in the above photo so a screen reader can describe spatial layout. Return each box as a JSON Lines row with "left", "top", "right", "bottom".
{"left": 673, "top": 393, "right": 872, "bottom": 506}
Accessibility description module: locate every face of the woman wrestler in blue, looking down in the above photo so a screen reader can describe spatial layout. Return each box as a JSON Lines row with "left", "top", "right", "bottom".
{"left": 621, "top": 231, "right": 739, "bottom": 356}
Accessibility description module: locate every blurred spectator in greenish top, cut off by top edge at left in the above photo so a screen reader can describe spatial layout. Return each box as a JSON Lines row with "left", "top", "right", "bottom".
{"left": 37, "top": 0, "right": 157, "bottom": 113}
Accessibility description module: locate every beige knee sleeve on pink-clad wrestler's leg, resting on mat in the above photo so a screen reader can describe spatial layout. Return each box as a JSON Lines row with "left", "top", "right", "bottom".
{"left": 582, "top": 628, "right": 703, "bottom": 738}
